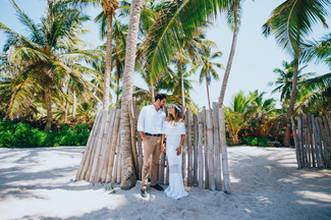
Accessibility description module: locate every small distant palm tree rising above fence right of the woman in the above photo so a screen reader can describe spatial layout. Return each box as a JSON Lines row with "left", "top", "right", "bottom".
{"left": 199, "top": 46, "right": 222, "bottom": 109}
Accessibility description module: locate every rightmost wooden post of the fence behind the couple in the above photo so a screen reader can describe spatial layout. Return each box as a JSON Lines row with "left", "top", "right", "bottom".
{"left": 218, "top": 106, "right": 231, "bottom": 193}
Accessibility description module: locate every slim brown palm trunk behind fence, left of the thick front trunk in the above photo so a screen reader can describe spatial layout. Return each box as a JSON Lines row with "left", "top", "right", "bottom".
{"left": 103, "top": 13, "right": 113, "bottom": 108}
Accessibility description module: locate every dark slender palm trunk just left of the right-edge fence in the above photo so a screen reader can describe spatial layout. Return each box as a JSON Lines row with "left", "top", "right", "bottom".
{"left": 283, "top": 55, "right": 299, "bottom": 147}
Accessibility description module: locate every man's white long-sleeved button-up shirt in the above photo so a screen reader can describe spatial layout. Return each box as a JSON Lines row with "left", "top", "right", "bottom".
{"left": 137, "top": 105, "right": 166, "bottom": 134}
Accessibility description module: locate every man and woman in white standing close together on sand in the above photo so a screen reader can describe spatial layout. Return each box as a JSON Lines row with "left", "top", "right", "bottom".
{"left": 138, "top": 94, "right": 188, "bottom": 199}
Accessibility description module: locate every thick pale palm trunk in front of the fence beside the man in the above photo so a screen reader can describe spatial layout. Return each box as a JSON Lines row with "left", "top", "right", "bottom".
{"left": 120, "top": 0, "right": 144, "bottom": 190}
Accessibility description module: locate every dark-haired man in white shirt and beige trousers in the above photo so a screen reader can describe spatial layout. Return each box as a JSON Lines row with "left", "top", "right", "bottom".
{"left": 137, "top": 94, "right": 167, "bottom": 197}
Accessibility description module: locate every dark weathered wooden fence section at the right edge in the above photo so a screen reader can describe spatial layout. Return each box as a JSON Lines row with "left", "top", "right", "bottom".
{"left": 292, "top": 112, "right": 331, "bottom": 169}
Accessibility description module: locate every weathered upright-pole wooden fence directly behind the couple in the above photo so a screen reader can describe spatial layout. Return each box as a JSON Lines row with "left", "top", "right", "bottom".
{"left": 76, "top": 103, "right": 230, "bottom": 193}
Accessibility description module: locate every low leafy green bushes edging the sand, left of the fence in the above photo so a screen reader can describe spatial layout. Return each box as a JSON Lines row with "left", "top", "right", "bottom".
{"left": 0, "top": 121, "right": 90, "bottom": 147}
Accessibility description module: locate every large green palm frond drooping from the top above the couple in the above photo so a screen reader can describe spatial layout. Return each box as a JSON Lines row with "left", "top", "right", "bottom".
{"left": 142, "top": 0, "right": 231, "bottom": 81}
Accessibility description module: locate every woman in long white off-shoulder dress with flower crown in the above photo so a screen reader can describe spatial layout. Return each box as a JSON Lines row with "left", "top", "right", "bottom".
{"left": 162, "top": 105, "right": 188, "bottom": 199}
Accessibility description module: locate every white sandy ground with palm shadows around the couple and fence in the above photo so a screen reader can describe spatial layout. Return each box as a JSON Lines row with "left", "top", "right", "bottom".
{"left": 0, "top": 147, "right": 331, "bottom": 220}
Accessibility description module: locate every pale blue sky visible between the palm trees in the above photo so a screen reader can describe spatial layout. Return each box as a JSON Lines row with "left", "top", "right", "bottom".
{"left": 0, "top": 0, "right": 331, "bottom": 107}
